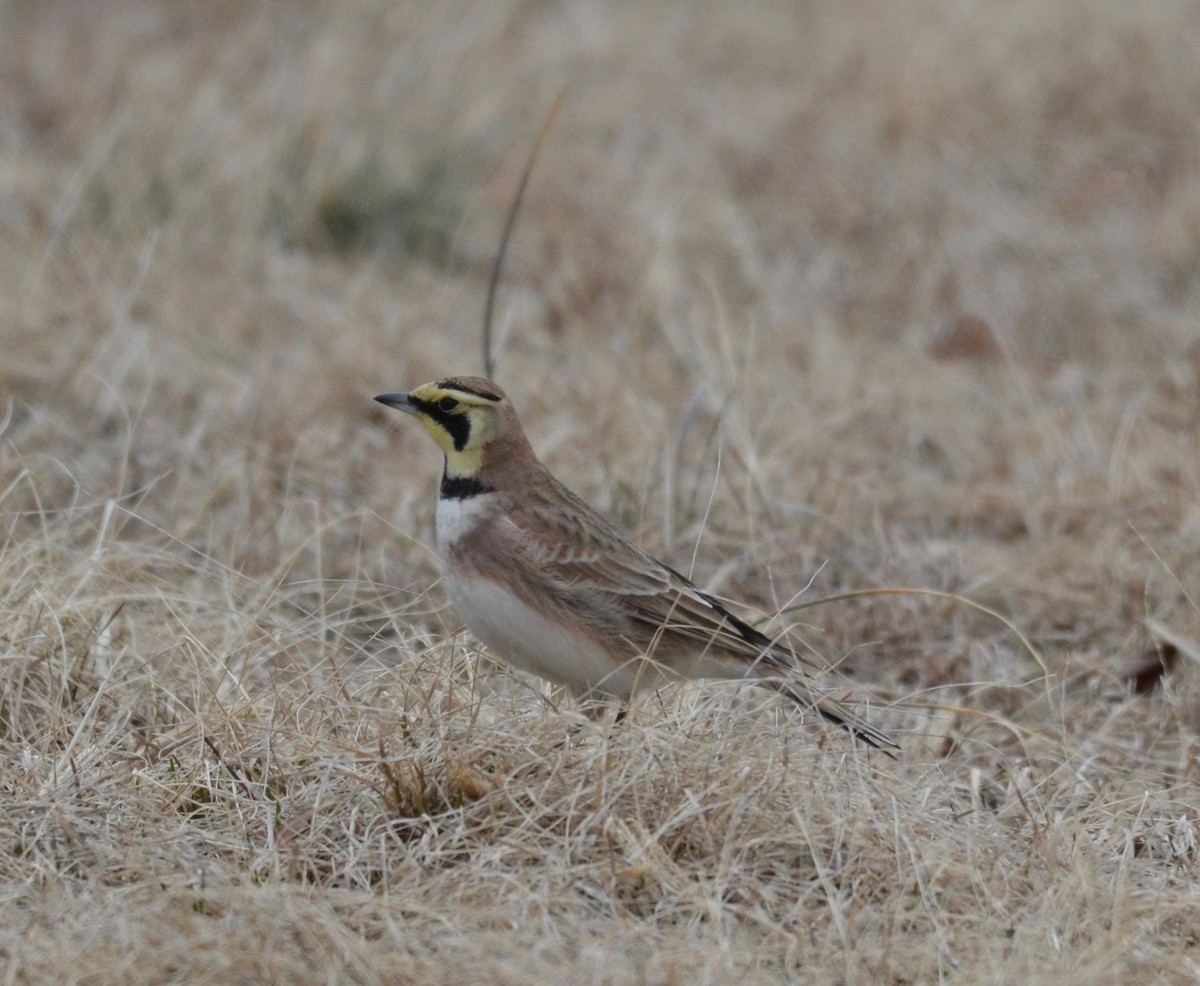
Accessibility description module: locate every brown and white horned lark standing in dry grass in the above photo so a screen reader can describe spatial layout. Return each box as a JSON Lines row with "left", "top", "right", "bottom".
{"left": 376, "top": 377, "right": 899, "bottom": 750}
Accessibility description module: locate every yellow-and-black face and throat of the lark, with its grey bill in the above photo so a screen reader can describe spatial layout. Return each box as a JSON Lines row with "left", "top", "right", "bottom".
{"left": 376, "top": 379, "right": 500, "bottom": 477}
